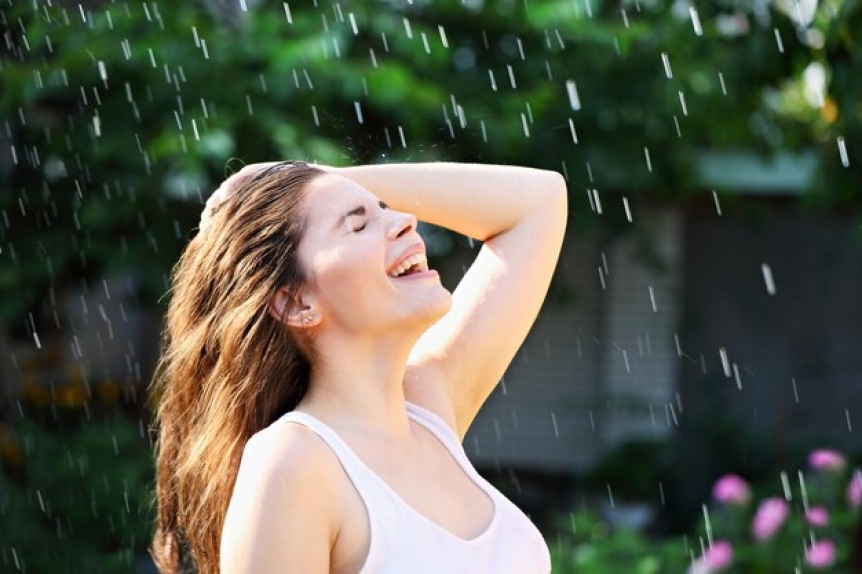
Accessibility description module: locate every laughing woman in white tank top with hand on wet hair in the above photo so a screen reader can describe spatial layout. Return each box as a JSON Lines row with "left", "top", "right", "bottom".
{"left": 153, "top": 162, "right": 566, "bottom": 574}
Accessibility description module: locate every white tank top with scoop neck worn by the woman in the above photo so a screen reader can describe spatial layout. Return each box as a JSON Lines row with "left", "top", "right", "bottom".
{"left": 280, "top": 403, "right": 551, "bottom": 574}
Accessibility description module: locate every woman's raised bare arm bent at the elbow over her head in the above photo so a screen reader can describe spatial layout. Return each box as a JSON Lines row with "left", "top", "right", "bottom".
{"left": 333, "top": 163, "right": 567, "bottom": 438}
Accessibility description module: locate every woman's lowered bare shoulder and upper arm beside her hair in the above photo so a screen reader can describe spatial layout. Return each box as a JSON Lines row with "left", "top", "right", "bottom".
{"left": 221, "top": 422, "right": 340, "bottom": 574}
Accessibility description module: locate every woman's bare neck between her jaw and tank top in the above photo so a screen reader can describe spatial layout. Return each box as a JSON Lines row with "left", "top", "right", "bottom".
{"left": 300, "top": 329, "right": 414, "bottom": 440}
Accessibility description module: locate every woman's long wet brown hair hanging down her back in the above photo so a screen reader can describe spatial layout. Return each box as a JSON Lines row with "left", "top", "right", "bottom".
{"left": 151, "top": 162, "right": 323, "bottom": 574}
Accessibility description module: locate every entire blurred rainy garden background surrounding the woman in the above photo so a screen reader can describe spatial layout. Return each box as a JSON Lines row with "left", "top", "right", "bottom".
{"left": 0, "top": 0, "right": 862, "bottom": 573}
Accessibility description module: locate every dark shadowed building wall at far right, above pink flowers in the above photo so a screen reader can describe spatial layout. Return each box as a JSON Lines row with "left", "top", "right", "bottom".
{"left": 679, "top": 199, "right": 862, "bottom": 512}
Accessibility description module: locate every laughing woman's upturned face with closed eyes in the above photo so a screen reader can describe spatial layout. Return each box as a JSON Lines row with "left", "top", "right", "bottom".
{"left": 300, "top": 174, "right": 451, "bottom": 335}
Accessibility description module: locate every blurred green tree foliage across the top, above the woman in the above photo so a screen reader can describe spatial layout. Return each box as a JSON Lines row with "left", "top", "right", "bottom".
{"left": 0, "top": 0, "right": 862, "bottom": 325}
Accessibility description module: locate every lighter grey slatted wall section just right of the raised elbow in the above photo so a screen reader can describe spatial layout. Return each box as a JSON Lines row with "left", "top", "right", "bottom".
{"left": 465, "top": 208, "right": 683, "bottom": 473}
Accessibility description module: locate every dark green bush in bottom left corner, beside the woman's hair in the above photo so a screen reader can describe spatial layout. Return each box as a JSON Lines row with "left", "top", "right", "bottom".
{"left": 0, "top": 412, "right": 152, "bottom": 574}
